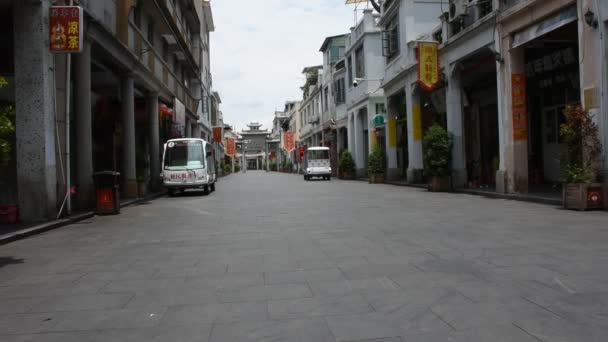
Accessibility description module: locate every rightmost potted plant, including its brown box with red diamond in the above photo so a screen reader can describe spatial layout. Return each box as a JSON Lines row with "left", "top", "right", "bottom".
{"left": 560, "top": 105, "right": 604, "bottom": 210}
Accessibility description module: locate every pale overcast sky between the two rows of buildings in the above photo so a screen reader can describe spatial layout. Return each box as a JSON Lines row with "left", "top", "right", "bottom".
{"left": 211, "top": 0, "right": 364, "bottom": 130}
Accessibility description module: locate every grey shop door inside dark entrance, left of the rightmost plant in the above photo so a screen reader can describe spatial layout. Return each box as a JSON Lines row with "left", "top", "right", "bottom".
{"left": 542, "top": 106, "right": 564, "bottom": 182}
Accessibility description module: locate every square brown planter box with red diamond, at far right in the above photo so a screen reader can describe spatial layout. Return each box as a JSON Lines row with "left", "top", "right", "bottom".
{"left": 562, "top": 183, "right": 606, "bottom": 211}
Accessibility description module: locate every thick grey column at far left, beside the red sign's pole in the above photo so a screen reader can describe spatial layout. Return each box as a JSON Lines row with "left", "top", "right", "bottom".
{"left": 13, "top": 1, "right": 57, "bottom": 222}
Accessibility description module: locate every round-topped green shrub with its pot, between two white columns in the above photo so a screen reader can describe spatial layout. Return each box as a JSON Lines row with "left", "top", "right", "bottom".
{"left": 422, "top": 125, "right": 452, "bottom": 192}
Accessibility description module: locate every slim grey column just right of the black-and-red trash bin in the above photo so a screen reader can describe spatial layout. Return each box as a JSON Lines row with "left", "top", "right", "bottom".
{"left": 121, "top": 75, "right": 137, "bottom": 198}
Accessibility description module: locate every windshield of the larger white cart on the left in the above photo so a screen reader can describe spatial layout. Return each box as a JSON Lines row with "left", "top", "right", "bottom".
{"left": 164, "top": 140, "right": 205, "bottom": 170}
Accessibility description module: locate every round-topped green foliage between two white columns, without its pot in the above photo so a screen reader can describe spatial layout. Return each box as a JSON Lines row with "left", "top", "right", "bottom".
{"left": 422, "top": 125, "right": 452, "bottom": 177}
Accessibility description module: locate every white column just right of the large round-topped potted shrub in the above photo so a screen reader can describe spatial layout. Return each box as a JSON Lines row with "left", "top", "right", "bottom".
{"left": 447, "top": 71, "right": 467, "bottom": 188}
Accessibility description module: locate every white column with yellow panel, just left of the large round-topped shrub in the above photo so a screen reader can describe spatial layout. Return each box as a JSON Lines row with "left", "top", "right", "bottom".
{"left": 405, "top": 84, "right": 424, "bottom": 183}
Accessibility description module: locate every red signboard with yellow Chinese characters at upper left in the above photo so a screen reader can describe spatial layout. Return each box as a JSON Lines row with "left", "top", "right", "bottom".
{"left": 49, "top": 6, "right": 83, "bottom": 52}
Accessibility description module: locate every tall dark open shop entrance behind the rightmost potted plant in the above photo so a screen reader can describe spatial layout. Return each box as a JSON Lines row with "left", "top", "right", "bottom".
{"left": 524, "top": 22, "right": 580, "bottom": 187}
